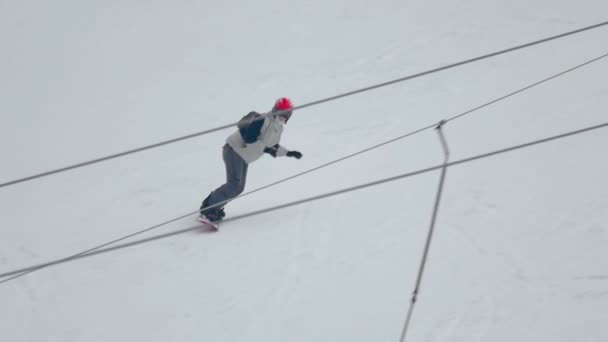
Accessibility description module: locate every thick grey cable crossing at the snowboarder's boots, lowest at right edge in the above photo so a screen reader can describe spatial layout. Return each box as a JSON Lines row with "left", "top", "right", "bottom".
{"left": 0, "top": 122, "right": 608, "bottom": 284}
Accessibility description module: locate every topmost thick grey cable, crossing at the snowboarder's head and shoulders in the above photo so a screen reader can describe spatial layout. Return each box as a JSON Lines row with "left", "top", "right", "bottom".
{"left": 0, "top": 21, "right": 608, "bottom": 188}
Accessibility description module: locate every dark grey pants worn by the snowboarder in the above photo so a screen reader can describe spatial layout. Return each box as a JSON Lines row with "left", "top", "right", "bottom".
{"left": 201, "top": 144, "right": 248, "bottom": 209}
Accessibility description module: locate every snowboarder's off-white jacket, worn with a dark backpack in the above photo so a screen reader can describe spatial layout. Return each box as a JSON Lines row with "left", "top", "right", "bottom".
{"left": 226, "top": 114, "right": 288, "bottom": 164}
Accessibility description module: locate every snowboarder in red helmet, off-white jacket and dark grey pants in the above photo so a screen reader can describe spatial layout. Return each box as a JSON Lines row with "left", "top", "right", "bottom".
{"left": 199, "top": 97, "right": 302, "bottom": 222}
